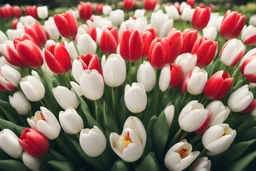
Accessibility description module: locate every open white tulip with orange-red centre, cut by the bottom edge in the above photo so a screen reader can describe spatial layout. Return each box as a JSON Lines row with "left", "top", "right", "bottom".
{"left": 164, "top": 140, "right": 200, "bottom": 170}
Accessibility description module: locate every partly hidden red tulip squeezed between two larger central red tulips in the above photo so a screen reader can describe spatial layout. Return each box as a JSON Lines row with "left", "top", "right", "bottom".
{"left": 142, "top": 28, "right": 157, "bottom": 57}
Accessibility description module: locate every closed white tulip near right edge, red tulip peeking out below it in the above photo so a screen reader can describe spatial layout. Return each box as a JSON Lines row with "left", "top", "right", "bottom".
{"left": 228, "top": 85, "right": 253, "bottom": 112}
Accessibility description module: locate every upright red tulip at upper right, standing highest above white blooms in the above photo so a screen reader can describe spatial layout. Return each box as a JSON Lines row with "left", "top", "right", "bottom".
{"left": 191, "top": 6, "right": 211, "bottom": 30}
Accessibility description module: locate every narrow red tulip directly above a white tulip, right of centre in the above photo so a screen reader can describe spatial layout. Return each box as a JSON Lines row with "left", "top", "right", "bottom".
{"left": 181, "top": 29, "right": 198, "bottom": 53}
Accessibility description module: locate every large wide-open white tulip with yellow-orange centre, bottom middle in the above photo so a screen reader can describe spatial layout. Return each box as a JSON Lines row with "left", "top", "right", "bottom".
{"left": 109, "top": 116, "right": 147, "bottom": 162}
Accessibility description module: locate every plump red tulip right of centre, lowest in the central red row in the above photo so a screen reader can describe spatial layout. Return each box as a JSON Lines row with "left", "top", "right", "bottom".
{"left": 148, "top": 38, "right": 170, "bottom": 69}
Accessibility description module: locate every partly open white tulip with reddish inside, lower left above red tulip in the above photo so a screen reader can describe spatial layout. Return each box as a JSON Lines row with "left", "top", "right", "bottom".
{"left": 27, "top": 107, "right": 60, "bottom": 140}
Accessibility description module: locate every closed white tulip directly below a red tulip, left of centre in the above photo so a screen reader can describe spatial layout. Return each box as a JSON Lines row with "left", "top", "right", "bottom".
{"left": 80, "top": 70, "right": 104, "bottom": 100}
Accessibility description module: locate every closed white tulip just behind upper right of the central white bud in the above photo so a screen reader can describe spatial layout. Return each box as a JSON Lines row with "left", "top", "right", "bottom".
{"left": 137, "top": 61, "right": 156, "bottom": 92}
